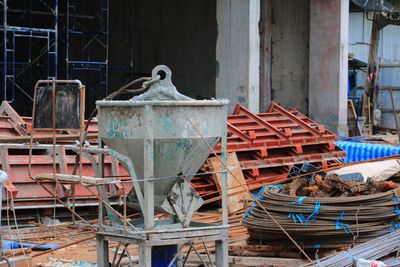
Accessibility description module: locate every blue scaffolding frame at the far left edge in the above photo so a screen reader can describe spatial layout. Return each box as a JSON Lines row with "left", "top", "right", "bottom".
{"left": 0, "top": 0, "right": 58, "bottom": 102}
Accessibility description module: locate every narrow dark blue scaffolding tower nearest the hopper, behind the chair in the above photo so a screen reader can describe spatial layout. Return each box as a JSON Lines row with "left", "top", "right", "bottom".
{"left": 66, "top": 0, "right": 109, "bottom": 99}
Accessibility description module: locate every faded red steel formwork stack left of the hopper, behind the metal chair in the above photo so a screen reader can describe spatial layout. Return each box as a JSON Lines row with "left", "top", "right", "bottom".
{"left": 0, "top": 144, "right": 132, "bottom": 209}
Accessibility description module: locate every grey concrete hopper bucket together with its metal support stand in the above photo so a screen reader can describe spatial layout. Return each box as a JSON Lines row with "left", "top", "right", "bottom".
{"left": 96, "top": 65, "right": 228, "bottom": 267}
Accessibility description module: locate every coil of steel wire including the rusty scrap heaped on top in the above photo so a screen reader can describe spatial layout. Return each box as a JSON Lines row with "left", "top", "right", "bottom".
{"left": 243, "top": 174, "right": 400, "bottom": 249}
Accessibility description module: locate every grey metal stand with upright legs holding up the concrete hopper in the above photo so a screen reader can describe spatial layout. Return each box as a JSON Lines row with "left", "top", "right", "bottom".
{"left": 97, "top": 127, "right": 228, "bottom": 267}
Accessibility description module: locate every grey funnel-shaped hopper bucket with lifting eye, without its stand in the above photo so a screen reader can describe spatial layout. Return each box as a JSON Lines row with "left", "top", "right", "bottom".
{"left": 96, "top": 66, "right": 228, "bottom": 220}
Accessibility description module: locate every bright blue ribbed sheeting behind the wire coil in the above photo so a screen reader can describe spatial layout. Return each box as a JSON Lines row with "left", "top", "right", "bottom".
{"left": 336, "top": 141, "right": 400, "bottom": 162}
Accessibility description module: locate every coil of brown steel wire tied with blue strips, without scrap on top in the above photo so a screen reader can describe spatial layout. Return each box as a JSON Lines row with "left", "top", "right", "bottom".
{"left": 243, "top": 186, "right": 400, "bottom": 249}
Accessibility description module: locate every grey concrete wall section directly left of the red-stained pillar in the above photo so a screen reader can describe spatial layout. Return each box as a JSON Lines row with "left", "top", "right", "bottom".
{"left": 270, "top": 0, "right": 310, "bottom": 113}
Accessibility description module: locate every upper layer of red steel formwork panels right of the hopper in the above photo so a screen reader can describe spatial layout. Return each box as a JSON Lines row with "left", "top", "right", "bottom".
{"left": 216, "top": 103, "right": 336, "bottom": 156}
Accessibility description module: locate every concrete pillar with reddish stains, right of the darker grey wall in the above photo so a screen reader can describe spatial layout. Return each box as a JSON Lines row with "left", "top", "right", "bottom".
{"left": 309, "top": 0, "right": 349, "bottom": 136}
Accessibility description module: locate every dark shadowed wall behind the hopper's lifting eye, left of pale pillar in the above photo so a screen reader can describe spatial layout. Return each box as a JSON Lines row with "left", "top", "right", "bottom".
{"left": 110, "top": 0, "right": 217, "bottom": 99}
